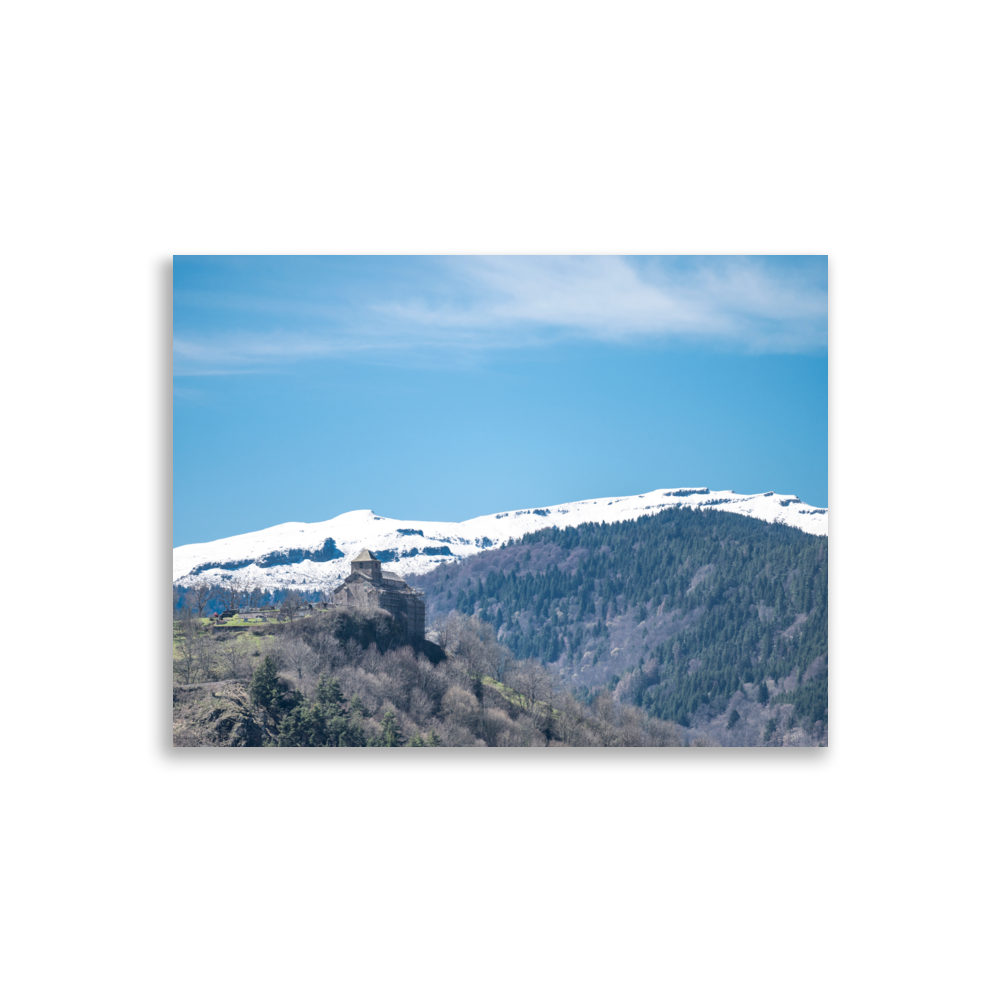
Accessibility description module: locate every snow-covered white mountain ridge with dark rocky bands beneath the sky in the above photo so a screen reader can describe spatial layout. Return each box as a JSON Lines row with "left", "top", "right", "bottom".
{"left": 174, "top": 487, "right": 830, "bottom": 590}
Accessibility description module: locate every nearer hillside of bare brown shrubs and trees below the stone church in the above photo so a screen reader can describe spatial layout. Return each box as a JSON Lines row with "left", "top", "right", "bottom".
{"left": 174, "top": 610, "right": 688, "bottom": 747}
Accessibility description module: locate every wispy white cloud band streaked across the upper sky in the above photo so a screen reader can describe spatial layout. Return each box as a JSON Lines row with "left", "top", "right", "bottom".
{"left": 174, "top": 255, "right": 828, "bottom": 374}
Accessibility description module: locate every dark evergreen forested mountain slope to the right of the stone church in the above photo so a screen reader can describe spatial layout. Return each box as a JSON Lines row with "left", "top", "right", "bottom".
{"left": 410, "top": 509, "right": 829, "bottom": 742}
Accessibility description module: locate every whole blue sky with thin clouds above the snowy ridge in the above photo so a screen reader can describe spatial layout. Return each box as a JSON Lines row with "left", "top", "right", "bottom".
{"left": 173, "top": 255, "right": 829, "bottom": 546}
